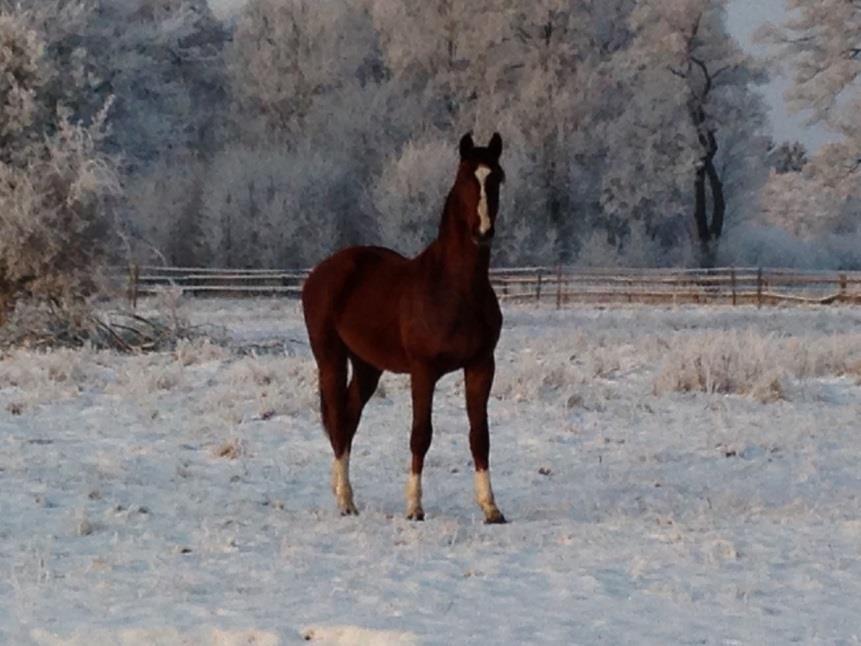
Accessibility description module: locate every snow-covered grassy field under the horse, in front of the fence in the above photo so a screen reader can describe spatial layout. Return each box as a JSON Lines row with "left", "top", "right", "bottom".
{"left": 0, "top": 300, "right": 861, "bottom": 646}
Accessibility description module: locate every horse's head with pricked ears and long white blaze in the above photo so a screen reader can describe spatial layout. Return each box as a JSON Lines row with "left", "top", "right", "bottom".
{"left": 455, "top": 132, "right": 505, "bottom": 246}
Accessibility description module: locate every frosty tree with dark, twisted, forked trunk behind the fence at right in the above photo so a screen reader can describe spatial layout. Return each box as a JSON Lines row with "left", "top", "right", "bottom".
{"left": 605, "top": 0, "right": 766, "bottom": 262}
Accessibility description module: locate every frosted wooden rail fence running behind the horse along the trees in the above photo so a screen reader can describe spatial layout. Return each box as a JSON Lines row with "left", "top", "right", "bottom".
{"left": 119, "top": 266, "right": 861, "bottom": 308}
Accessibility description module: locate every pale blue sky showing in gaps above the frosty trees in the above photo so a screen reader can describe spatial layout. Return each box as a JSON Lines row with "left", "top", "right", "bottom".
{"left": 209, "top": 0, "right": 832, "bottom": 151}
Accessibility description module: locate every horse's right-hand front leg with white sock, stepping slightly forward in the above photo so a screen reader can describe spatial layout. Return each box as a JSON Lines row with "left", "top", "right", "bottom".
{"left": 463, "top": 355, "right": 505, "bottom": 523}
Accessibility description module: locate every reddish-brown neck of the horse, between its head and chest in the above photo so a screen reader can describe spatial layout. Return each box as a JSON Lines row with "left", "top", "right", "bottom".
{"left": 428, "top": 195, "right": 490, "bottom": 288}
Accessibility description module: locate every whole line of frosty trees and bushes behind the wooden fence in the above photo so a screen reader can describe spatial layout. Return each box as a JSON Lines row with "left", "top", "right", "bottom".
{"left": 0, "top": 0, "right": 861, "bottom": 314}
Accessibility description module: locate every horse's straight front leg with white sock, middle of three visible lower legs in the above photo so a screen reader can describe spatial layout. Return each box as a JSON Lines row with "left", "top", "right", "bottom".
{"left": 406, "top": 365, "right": 439, "bottom": 520}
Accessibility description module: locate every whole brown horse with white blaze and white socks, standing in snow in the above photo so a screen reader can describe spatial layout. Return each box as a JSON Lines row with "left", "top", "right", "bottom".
{"left": 302, "top": 133, "right": 505, "bottom": 523}
